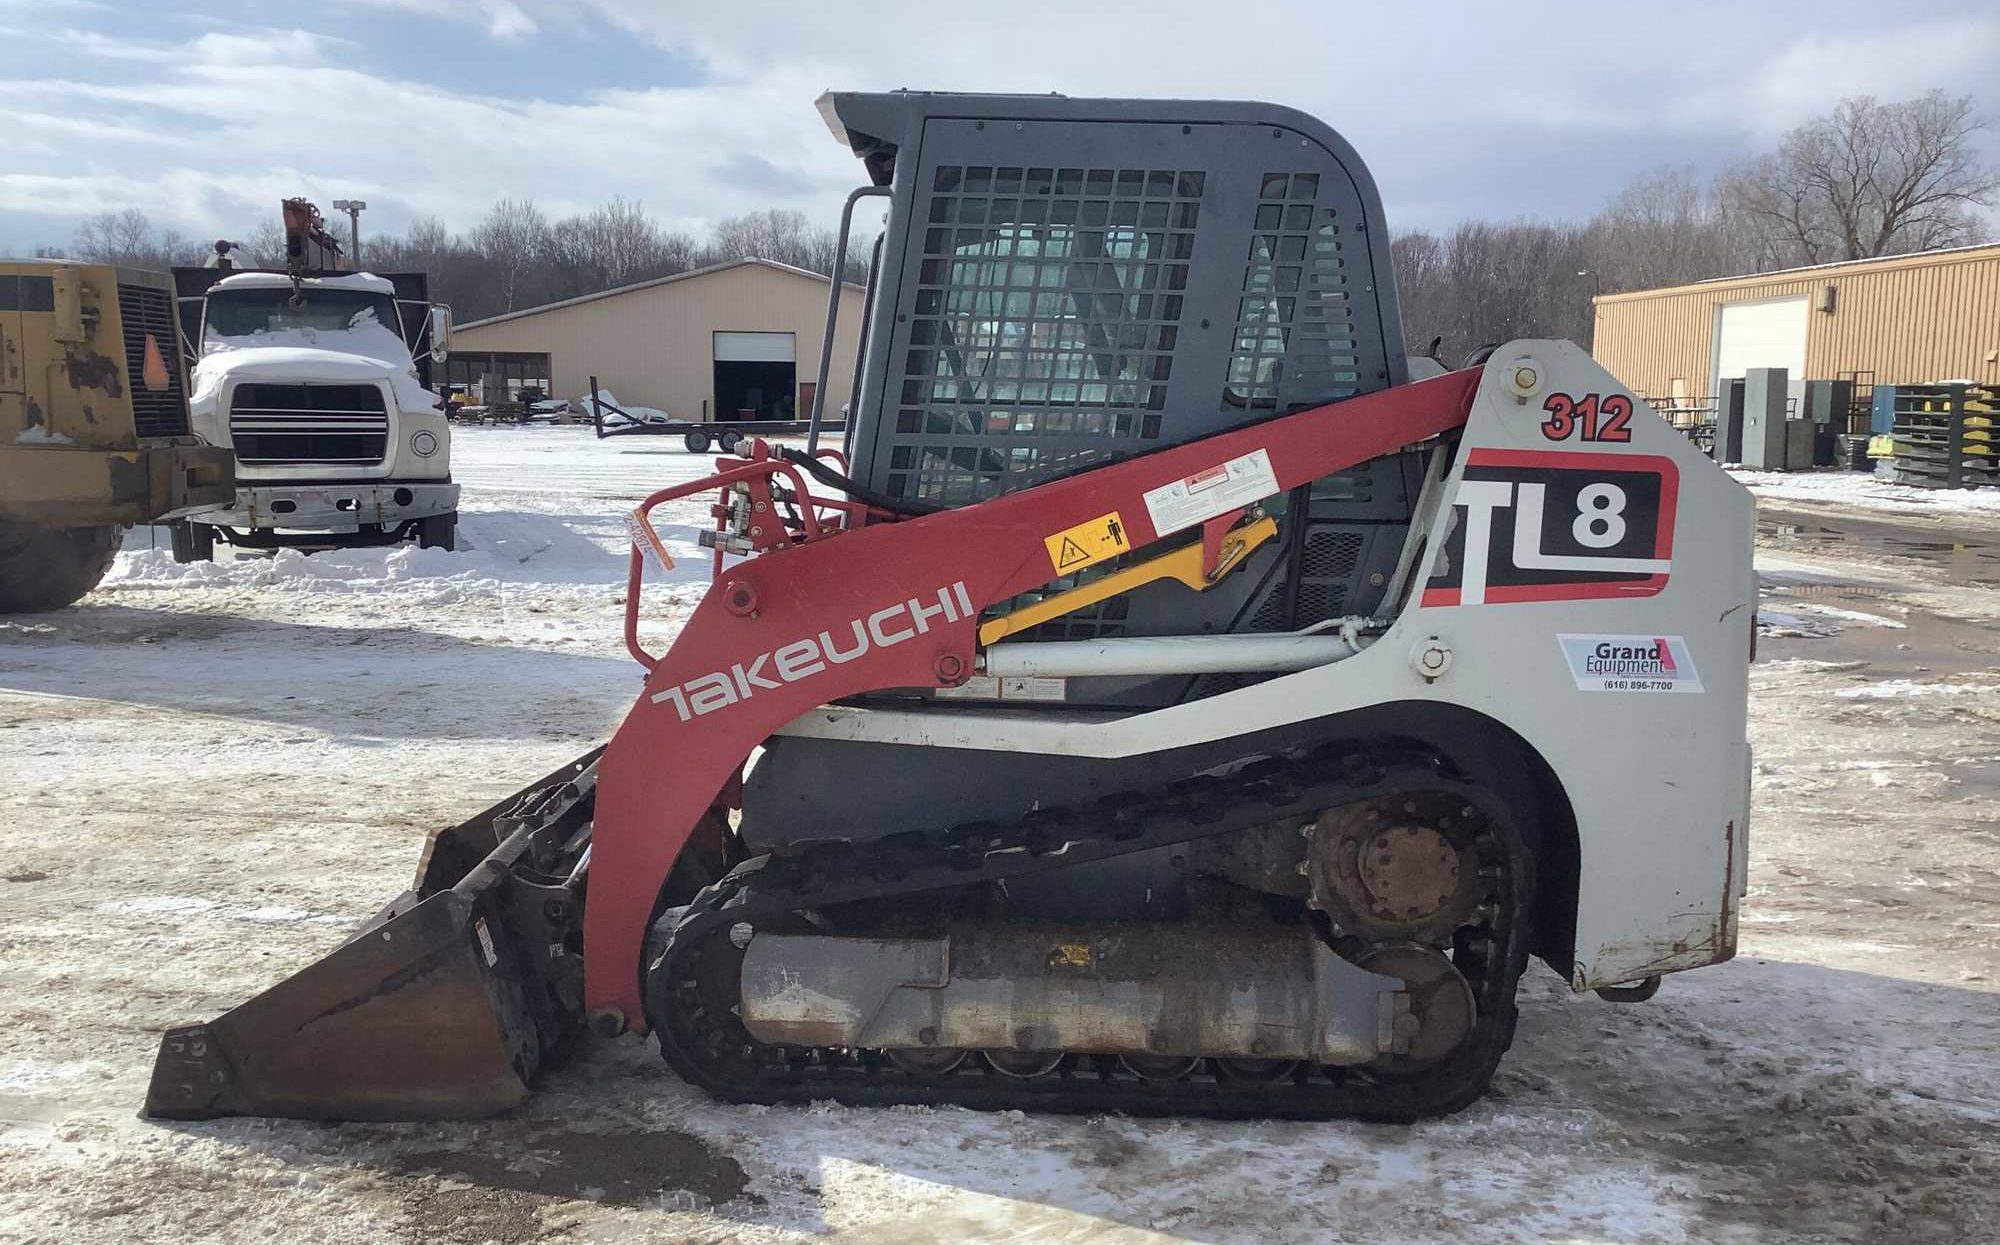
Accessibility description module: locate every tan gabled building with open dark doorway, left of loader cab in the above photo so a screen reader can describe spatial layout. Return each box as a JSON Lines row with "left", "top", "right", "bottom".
{"left": 454, "top": 260, "right": 862, "bottom": 420}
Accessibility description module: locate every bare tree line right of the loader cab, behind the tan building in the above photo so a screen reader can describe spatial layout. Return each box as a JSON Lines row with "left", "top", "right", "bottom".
{"left": 1390, "top": 90, "right": 2000, "bottom": 364}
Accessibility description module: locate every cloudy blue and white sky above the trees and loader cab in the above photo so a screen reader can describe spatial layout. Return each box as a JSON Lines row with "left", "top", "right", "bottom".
{"left": 0, "top": 0, "right": 2000, "bottom": 252}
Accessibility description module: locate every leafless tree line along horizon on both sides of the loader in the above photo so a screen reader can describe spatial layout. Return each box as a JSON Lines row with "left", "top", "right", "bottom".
{"left": 42, "top": 90, "right": 2000, "bottom": 352}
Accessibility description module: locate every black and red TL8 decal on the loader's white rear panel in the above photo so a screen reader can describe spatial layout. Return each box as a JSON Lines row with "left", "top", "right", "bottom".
{"left": 1422, "top": 450, "right": 1680, "bottom": 606}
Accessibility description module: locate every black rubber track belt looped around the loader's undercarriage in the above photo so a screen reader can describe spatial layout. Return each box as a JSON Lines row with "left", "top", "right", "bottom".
{"left": 646, "top": 745, "right": 1532, "bottom": 1121}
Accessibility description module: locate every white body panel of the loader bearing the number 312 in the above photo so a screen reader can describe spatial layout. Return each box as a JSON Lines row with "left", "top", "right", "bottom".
{"left": 784, "top": 340, "right": 1756, "bottom": 989}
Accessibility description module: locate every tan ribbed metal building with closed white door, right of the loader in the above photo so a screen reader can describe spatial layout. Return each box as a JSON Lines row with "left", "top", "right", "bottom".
{"left": 1592, "top": 246, "right": 2000, "bottom": 398}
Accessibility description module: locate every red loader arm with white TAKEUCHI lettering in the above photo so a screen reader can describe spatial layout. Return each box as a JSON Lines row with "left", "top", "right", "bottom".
{"left": 584, "top": 370, "right": 1478, "bottom": 1033}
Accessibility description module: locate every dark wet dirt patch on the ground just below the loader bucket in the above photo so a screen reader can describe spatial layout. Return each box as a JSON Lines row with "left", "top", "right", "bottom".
{"left": 396, "top": 1129, "right": 750, "bottom": 1216}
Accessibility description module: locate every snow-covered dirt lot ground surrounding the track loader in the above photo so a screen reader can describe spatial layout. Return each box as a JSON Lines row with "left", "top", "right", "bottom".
{"left": 0, "top": 428, "right": 2000, "bottom": 1245}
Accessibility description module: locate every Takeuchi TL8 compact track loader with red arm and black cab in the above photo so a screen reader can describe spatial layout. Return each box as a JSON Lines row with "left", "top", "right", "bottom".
{"left": 146, "top": 92, "right": 1756, "bottom": 1119}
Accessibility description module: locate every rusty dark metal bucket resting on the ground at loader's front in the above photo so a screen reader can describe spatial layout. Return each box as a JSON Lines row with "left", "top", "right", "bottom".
{"left": 144, "top": 753, "right": 596, "bottom": 1121}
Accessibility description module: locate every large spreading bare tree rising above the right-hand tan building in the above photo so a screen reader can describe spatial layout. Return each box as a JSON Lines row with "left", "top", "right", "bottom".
{"left": 1724, "top": 90, "right": 2000, "bottom": 264}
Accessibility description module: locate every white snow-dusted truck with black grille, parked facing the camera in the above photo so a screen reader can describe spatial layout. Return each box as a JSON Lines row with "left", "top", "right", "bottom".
{"left": 172, "top": 268, "right": 458, "bottom": 562}
